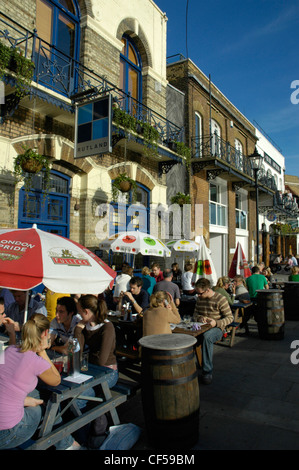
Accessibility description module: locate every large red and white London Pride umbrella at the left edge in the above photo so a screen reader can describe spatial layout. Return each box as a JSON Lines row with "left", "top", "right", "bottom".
{"left": 0, "top": 225, "right": 116, "bottom": 294}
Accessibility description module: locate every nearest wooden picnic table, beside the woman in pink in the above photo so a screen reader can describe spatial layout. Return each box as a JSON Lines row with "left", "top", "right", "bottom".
{"left": 26, "top": 364, "right": 127, "bottom": 450}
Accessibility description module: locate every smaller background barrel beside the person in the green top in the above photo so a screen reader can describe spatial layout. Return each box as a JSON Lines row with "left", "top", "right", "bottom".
{"left": 256, "top": 289, "right": 285, "bottom": 340}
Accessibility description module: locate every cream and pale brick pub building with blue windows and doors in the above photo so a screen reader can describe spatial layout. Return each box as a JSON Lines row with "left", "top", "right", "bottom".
{"left": 0, "top": 0, "right": 188, "bottom": 270}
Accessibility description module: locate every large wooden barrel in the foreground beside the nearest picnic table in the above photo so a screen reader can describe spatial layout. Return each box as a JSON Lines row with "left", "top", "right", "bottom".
{"left": 139, "top": 334, "right": 199, "bottom": 450}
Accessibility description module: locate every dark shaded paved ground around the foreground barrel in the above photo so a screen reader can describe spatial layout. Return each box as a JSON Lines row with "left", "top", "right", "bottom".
{"left": 119, "top": 276, "right": 299, "bottom": 450}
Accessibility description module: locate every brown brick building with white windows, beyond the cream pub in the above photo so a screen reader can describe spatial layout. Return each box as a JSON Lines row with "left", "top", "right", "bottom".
{"left": 167, "top": 56, "right": 277, "bottom": 277}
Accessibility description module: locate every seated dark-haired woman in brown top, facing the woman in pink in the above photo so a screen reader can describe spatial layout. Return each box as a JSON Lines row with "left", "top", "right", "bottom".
{"left": 74, "top": 295, "right": 118, "bottom": 388}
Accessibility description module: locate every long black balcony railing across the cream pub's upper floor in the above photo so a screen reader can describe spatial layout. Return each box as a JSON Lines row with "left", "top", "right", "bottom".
{"left": 0, "top": 13, "right": 184, "bottom": 144}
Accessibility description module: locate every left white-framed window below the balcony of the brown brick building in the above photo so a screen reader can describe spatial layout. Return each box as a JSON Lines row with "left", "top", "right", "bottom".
{"left": 209, "top": 183, "right": 227, "bottom": 227}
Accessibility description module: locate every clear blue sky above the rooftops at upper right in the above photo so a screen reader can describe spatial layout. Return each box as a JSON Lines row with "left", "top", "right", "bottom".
{"left": 155, "top": 0, "right": 299, "bottom": 176}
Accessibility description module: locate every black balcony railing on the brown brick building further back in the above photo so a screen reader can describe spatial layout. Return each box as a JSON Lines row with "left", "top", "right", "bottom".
{"left": 192, "top": 134, "right": 277, "bottom": 190}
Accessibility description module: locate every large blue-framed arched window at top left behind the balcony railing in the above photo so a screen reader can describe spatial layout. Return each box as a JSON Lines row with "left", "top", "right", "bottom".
{"left": 35, "top": 0, "right": 80, "bottom": 94}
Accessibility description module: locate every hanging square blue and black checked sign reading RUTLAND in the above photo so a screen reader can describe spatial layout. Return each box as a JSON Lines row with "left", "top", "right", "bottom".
{"left": 74, "top": 95, "right": 112, "bottom": 158}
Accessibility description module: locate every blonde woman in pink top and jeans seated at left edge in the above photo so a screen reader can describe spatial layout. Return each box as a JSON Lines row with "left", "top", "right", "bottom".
{"left": 0, "top": 313, "right": 80, "bottom": 450}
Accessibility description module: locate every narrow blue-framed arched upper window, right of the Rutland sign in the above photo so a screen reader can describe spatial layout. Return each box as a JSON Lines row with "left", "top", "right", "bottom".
{"left": 120, "top": 35, "right": 142, "bottom": 113}
